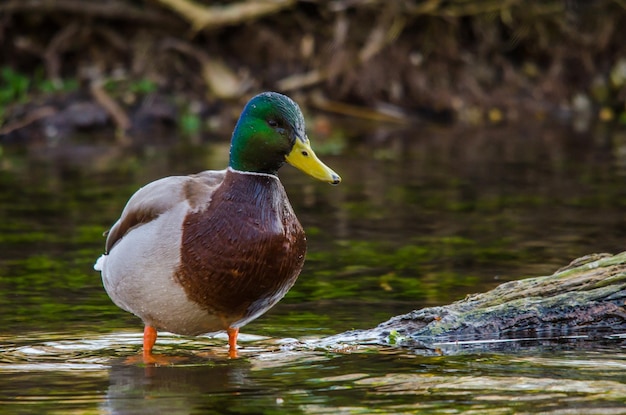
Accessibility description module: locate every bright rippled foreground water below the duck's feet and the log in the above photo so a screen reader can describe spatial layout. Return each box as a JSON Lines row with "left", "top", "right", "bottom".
{"left": 0, "top": 332, "right": 626, "bottom": 414}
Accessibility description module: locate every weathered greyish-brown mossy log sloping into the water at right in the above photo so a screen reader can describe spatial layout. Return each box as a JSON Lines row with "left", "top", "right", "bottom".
{"left": 324, "top": 252, "right": 626, "bottom": 348}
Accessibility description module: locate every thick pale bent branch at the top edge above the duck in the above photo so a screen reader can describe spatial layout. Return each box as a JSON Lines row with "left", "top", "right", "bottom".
{"left": 158, "top": 0, "right": 295, "bottom": 32}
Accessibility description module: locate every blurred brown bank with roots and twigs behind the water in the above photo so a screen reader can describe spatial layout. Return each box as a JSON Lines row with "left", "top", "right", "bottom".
{"left": 0, "top": 0, "right": 626, "bottom": 140}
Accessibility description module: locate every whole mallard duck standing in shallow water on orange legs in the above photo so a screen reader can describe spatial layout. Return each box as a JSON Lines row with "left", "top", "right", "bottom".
{"left": 94, "top": 92, "right": 341, "bottom": 362}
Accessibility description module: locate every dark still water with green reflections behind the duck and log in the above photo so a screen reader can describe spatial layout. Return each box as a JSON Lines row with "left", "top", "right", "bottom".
{"left": 0, "top": 124, "right": 626, "bottom": 333}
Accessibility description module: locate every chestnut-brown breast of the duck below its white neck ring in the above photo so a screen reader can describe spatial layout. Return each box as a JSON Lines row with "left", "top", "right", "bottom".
{"left": 175, "top": 171, "right": 306, "bottom": 324}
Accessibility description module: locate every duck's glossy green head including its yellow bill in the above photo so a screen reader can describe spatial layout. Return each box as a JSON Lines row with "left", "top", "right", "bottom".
{"left": 229, "top": 92, "right": 341, "bottom": 184}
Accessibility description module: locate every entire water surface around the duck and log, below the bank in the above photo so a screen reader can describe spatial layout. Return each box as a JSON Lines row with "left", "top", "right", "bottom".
{"left": 0, "top": 125, "right": 626, "bottom": 414}
